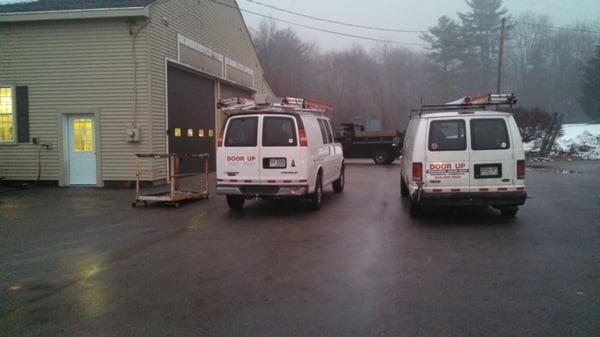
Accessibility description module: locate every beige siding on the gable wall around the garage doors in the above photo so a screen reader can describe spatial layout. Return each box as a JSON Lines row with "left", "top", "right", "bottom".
{"left": 148, "top": 0, "right": 271, "bottom": 178}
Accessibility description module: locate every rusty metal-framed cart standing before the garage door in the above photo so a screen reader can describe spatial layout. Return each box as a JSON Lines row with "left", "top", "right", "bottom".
{"left": 132, "top": 153, "right": 209, "bottom": 207}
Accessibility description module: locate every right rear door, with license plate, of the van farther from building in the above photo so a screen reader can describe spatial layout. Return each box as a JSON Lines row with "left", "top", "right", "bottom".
{"left": 469, "top": 116, "right": 516, "bottom": 192}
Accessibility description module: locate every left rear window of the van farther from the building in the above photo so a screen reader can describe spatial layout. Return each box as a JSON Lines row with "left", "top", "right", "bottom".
{"left": 428, "top": 120, "right": 467, "bottom": 151}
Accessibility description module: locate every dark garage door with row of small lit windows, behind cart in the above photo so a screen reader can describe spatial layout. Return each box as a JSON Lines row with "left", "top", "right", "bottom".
{"left": 168, "top": 66, "right": 216, "bottom": 174}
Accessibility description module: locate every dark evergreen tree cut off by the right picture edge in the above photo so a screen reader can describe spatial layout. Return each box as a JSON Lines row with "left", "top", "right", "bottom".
{"left": 579, "top": 46, "right": 600, "bottom": 121}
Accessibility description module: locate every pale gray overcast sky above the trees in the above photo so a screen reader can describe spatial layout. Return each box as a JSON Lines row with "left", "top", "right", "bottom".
{"left": 237, "top": 0, "right": 600, "bottom": 51}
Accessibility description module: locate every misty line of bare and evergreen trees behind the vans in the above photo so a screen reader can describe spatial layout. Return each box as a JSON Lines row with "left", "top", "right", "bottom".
{"left": 247, "top": 0, "right": 600, "bottom": 130}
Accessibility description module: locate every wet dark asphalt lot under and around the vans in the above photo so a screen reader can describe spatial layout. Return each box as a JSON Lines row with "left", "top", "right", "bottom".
{"left": 0, "top": 160, "right": 600, "bottom": 337}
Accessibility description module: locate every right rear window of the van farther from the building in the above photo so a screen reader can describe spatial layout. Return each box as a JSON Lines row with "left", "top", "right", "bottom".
{"left": 470, "top": 118, "right": 510, "bottom": 150}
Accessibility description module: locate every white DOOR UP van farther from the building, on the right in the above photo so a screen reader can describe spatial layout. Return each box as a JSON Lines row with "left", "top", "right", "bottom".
{"left": 400, "top": 94, "right": 527, "bottom": 216}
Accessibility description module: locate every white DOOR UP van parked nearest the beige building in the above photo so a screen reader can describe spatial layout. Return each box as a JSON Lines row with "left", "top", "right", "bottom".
{"left": 216, "top": 95, "right": 344, "bottom": 210}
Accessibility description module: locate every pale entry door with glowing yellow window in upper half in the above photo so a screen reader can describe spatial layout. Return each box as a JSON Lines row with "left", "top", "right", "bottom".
{"left": 67, "top": 115, "right": 96, "bottom": 185}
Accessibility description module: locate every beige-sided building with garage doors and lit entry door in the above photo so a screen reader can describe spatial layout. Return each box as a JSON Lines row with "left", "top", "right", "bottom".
{"left": 0, "top": 0, "right": 272, "bottom": 186}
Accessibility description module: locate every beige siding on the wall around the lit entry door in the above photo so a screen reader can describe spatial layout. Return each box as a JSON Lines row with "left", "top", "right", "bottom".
{"left": 0, "top": 19, "right": 149, "bottom": 181}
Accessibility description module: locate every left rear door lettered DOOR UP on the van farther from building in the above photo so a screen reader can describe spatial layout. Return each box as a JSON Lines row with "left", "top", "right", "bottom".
{"left": 424, "top": 118, "right": 470, "bottom": 193}
